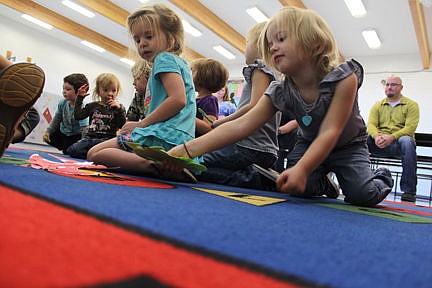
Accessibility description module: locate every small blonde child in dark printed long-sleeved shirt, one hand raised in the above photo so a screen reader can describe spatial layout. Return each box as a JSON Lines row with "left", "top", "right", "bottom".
{"left": 66, "top": 73, "right": 126, "bottom": 159}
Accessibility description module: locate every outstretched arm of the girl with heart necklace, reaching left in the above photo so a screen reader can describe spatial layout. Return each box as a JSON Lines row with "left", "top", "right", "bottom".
{"left": 168, "top": 96, "right": 277, "bottom": 158}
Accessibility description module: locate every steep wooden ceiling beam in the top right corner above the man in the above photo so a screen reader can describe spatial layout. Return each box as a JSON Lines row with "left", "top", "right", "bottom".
{"left": 408, "top": 0, "right": 430, "bottom": 69}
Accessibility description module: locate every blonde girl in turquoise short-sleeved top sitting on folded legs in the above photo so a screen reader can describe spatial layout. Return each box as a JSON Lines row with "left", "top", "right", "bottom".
{"left": 87, "top": 4, "right": 196, "bottom": 181}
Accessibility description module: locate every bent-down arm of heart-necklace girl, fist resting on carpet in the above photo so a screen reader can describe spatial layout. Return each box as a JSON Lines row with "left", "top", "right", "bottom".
{"left": 276, "top": 74, "right": 357, "bottom": 194}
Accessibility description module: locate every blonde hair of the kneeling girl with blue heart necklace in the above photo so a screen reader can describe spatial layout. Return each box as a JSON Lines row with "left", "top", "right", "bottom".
{"left": 260, "top": 6, "right": 339, "bottom": 76}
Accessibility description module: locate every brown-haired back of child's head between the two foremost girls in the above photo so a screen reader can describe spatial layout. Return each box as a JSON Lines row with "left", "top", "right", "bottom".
{"left": 190, "top": 58, "right": 229, "bottom": 93}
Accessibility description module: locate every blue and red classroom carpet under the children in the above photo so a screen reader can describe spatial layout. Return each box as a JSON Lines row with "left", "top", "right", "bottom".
{"left": 0, "top": 149, "right": 432, "bottom": 287}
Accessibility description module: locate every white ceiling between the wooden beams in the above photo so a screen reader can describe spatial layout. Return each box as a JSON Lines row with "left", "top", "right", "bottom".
{"left": 0, "top": 0, "right": 432, "bottom": 77}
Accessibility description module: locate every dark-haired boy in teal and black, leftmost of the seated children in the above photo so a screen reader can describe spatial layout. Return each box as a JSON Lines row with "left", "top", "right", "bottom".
{"left": 43, "top": 73, "right": 89, "bottom": 154}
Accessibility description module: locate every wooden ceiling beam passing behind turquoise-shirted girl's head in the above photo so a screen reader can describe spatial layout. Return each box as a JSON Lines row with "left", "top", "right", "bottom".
{"left": 78, "top": 0, "right": 204, "bottom": 61}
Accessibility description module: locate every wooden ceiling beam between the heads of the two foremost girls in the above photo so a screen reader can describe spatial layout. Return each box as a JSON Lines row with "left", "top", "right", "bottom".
{"left": 169, "top": 0, "right": 246, "bottom": 54}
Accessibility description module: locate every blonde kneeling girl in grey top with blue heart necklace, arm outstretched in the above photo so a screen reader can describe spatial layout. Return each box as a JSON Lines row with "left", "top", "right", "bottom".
{"left": 167, "top": 7, "right": 393, "bottom": 206}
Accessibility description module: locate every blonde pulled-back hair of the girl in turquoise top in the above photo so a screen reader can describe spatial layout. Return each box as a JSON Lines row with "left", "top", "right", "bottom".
{"left": 127, "top": 4, "right": 184, "bottom": 55}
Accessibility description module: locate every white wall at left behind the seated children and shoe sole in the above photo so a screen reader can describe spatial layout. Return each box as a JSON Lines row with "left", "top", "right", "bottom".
{"left": 0, "top": 17, "right": 134, "bottom": 107}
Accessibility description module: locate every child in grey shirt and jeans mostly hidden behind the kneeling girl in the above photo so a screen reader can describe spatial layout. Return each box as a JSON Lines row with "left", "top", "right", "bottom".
{"left": 165, "top": 23, "right": 278, "bottom": 188}
